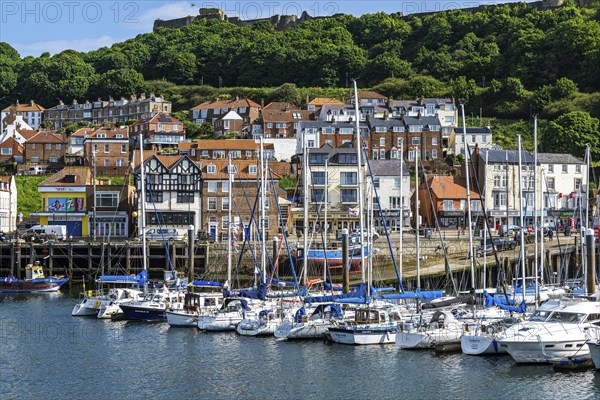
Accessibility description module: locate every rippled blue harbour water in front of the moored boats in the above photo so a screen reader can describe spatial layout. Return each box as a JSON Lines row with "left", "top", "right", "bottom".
{"left": 0, "top": 294, "right": 600, "bottom": 399}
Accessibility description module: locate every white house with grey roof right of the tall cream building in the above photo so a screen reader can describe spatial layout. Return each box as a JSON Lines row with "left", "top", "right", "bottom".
{"left": 367, "top": 160, "right": 411, "bottom": 231}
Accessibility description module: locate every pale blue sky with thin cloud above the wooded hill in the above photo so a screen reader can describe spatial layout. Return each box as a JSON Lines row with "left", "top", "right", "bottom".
{"left": 0, "top": 0, "right": 502, "bottom": 57}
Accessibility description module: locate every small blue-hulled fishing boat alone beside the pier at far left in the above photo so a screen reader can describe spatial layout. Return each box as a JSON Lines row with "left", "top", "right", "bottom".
{"left": 0, "top": 261, "right": 69, "bottom": 293}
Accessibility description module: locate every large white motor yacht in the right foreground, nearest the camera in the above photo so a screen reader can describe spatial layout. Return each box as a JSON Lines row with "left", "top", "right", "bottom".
{"left": 498, "top": 298, "right": 600, "bottom": 363}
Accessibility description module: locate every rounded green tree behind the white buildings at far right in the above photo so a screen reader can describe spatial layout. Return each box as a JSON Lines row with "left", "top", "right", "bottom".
{"left": 541, "top": 111, "right": 600, "bottom": 160}
